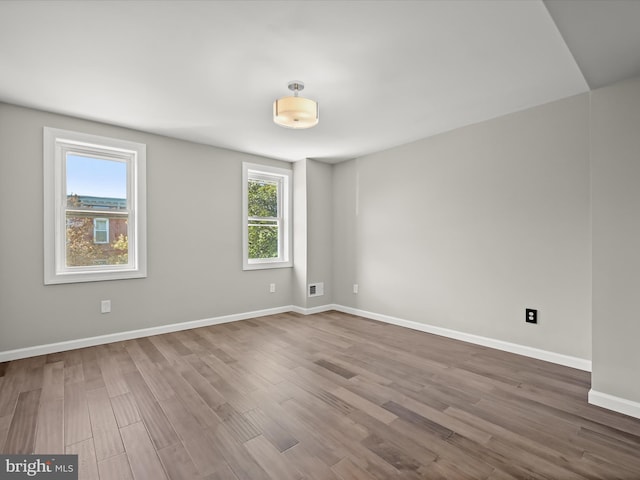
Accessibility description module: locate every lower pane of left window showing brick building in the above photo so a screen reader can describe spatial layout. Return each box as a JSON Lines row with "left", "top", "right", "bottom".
{"left": 66, "top": 212, "right": 129, "bottom": 267}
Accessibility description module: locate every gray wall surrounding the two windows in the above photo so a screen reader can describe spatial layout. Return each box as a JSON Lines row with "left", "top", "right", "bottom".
{"left": 0, "top": 104, "right": 292, "bottom": 351}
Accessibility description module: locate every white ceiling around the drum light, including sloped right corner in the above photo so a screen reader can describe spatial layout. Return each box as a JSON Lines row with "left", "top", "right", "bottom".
{"left": 0, "top": 0, "right": 640, "bottom": 162}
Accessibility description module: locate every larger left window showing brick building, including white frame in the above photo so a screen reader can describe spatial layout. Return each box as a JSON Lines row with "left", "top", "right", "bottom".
{"left": 44, "top": 127, "right": 146, "bottom": 284}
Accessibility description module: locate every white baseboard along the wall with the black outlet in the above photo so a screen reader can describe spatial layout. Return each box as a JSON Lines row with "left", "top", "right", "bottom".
{"left": 332, "top": 305, "right": 591, "bottom": 372}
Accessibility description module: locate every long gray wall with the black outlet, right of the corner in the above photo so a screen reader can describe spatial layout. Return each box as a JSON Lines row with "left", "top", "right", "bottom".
{"left": 333, "top": 95, "right": 591, "bottom": 359}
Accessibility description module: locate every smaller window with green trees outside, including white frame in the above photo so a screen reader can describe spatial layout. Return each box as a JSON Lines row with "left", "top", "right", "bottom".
{"left": 242, "top": 163, "right": 292, "bottom": 270}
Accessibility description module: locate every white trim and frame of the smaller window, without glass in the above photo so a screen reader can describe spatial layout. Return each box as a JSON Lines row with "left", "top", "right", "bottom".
{"left": 242, "top": 162, "right": 293, "bottom": 270}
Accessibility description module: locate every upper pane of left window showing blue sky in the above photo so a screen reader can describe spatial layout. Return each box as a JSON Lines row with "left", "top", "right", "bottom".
{"left": 66, "top": 153, "right": 127, "bottom": 210}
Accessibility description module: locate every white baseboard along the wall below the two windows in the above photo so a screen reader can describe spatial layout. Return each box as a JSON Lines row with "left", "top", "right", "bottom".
{"left": 0, "top": 305, "right": 293, "bottom": 362}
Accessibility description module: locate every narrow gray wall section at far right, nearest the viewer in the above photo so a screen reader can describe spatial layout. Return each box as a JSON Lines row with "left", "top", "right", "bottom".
{"left": 591, "top": 78, "right": 640, "bottom": 402}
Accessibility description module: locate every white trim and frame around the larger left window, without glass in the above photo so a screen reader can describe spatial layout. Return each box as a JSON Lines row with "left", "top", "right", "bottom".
{"left": 43, "top": 127, "right": 147, "bottom": 285}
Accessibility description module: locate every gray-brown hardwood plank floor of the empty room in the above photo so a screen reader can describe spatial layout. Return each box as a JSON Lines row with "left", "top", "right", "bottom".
{"left": 0, "top": 312, "right": 640, "bottom": 480}
